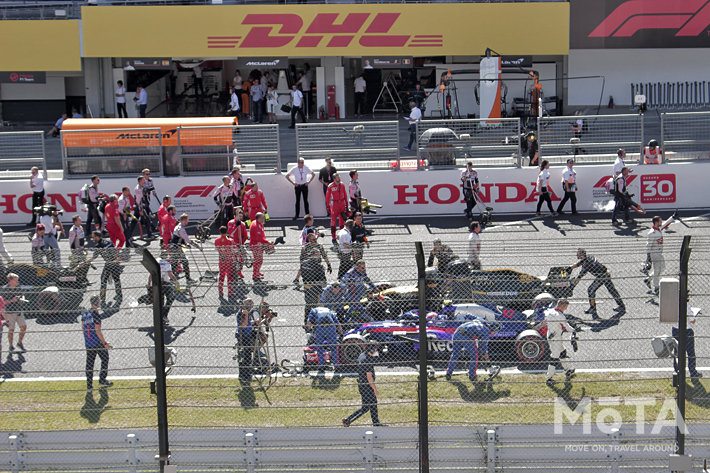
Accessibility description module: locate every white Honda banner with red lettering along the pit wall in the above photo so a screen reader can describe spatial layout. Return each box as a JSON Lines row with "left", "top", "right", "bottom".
{"left": 0, "top": 162, "right": 710, "bottom": 223}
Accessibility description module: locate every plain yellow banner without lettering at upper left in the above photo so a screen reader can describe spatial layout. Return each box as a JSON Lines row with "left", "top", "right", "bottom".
{"left": 0, "top": 20, "right": 81, "bottom": 71}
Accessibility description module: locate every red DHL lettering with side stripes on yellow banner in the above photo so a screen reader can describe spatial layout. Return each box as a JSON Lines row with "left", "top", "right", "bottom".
{"left": 207, "top": 13, "right": 444, "bottom": 49}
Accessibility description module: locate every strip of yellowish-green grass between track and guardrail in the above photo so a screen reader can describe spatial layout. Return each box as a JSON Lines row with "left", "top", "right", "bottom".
{"left": 0, "top": 374, "right": 710, "bottom": 431}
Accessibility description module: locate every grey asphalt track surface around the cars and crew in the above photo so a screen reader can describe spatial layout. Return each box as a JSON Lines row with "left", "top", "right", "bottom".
{"left": 0, "top": 210, "right": 710, "bottom": 378}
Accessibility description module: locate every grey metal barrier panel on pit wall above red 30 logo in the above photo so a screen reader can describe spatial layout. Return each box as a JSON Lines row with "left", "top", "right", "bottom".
{"left": 661, "top": 112, "right": 710, "bottom": 161}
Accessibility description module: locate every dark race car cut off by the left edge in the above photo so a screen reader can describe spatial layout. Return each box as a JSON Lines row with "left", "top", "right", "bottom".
{"left": 3, "top": 262, "right": 90, "bottom": 316}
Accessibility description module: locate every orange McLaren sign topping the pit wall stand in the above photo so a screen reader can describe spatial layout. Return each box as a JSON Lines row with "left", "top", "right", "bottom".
{"left": 62, "top": 117, "right": 238, "bottom": 148}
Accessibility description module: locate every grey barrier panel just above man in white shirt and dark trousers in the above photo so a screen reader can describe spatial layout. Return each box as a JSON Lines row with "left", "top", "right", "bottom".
{"left": 296, "top": 121, "right": 400, "bottom": 164}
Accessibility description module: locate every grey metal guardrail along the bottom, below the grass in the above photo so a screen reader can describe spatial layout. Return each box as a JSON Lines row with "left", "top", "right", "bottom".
{"left": 0, "top": 424, "right": 710, "bottom": 473}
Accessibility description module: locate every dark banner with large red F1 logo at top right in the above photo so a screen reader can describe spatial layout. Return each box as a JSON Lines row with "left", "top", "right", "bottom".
{"left": 570, "top": 0, "right": 710, "bottom": 49}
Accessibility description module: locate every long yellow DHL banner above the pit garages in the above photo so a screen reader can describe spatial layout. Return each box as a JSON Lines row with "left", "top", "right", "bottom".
{"left": 82, "top": 2, "right": 569, "bottom": 58}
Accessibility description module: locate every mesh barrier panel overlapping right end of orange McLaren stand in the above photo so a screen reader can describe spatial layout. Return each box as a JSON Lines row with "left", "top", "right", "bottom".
{"left": 178, "top": 125, "right": 281, "bottom": 176}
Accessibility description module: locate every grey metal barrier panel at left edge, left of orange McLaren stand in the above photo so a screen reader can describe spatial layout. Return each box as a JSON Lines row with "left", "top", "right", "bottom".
{"left": 0, "top": 131, "right": 47, "bottom": 179}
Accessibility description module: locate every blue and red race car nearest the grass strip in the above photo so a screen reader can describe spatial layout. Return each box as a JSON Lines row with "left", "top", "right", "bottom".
{"left": 304, "top": 303, "right": 550, "bottom": 368}
